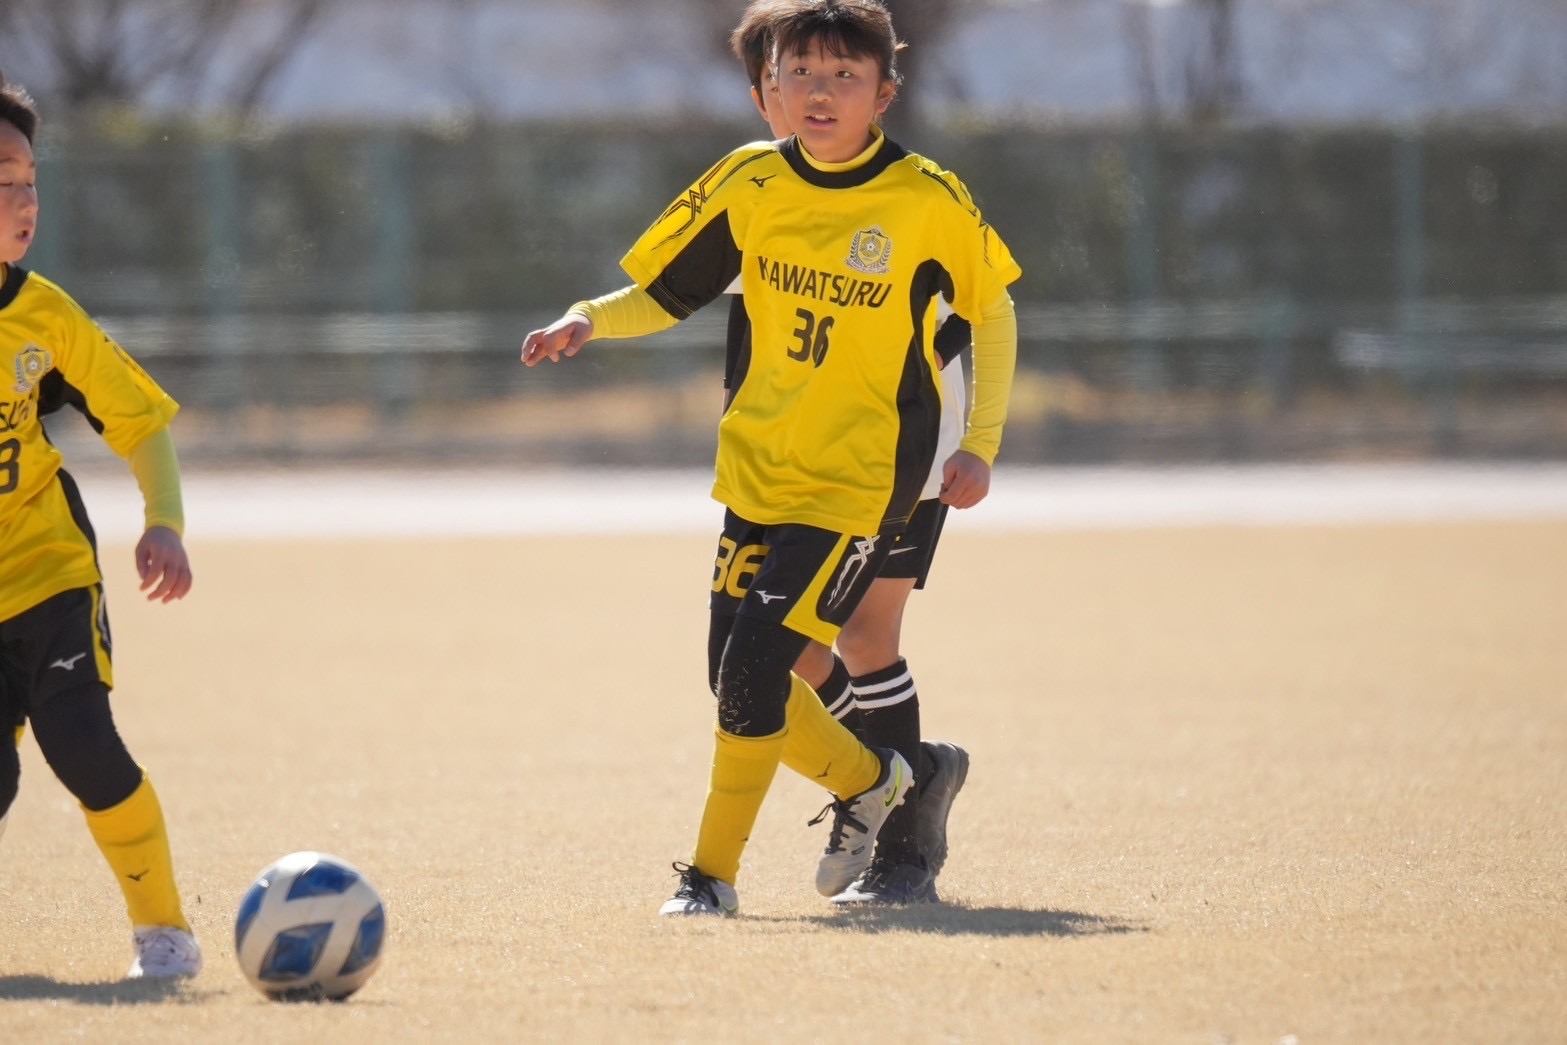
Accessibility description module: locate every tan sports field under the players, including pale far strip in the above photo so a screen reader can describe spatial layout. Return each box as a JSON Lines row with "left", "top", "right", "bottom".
{"left": 0, "top": 468, "right": 1567, "bottom": 1045}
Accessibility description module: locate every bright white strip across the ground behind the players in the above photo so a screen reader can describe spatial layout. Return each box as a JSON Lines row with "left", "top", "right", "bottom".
{"left": 64, "top": 464, "right": 1567, "bottom": 542}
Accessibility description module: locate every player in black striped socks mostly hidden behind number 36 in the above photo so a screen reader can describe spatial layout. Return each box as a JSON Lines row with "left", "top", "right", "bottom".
{"left": 724, "top": 0, "right": 984, "bottom": 904}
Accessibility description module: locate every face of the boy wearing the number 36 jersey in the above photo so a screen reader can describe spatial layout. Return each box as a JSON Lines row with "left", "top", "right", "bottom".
{"left": 769, "top": 41, "right": 893, "bottom": 163}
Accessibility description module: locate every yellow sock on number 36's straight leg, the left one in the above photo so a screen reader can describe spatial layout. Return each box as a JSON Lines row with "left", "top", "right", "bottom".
{"left": 691, "top": 726, "right": 789, "bottom": 885}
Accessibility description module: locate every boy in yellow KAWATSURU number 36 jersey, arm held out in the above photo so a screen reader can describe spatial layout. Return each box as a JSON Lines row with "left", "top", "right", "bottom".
{"left": 522, "top": 0, "right": 1019, "bottom": 913}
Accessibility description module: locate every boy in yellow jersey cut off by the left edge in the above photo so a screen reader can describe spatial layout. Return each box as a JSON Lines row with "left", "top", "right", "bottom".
{"left": 0, "top": 85, "right": 201, "bottom": 978}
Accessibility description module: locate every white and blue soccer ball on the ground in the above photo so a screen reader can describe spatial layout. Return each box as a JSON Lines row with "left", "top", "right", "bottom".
{"left": 233, "top": 852, "right": 387, "bottom": 1001}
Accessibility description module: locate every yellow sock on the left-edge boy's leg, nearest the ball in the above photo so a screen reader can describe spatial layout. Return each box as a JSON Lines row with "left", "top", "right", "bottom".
{"left": 81, "top": 774, "right": 191, "bottom": 932}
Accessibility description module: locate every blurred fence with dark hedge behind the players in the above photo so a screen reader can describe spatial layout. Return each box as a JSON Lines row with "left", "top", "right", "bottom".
{"left": 28, "top": 125, "right": 1567, "bottom": 464}
